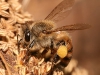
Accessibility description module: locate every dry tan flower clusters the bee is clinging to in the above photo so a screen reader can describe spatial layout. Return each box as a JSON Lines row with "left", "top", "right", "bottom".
{"left": 0, "top": 0, "right": 88, "bottom": 75}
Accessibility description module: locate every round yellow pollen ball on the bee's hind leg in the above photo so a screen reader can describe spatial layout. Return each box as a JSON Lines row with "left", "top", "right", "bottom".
{"left": 57, "top": 45, "right": 68, "bottom": 58}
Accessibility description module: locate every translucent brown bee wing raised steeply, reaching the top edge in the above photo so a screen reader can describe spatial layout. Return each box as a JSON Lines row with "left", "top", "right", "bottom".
{"left": 45, "top": 0, "right": 74, "bottom": 22}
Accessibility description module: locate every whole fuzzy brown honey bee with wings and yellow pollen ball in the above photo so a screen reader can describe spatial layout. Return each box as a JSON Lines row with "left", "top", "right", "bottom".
{"left": 18, "top": 0, "right": 90, "bottom": 74}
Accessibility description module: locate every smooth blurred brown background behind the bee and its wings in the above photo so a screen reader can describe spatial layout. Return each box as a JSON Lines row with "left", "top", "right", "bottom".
{"left": 20, "top": 0, "right": 100, "bottom": 75}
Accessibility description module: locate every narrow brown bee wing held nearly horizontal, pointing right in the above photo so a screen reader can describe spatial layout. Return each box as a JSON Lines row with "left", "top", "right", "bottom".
{"left": 45, "top": 24, "right": 91, "bottom": 34}
